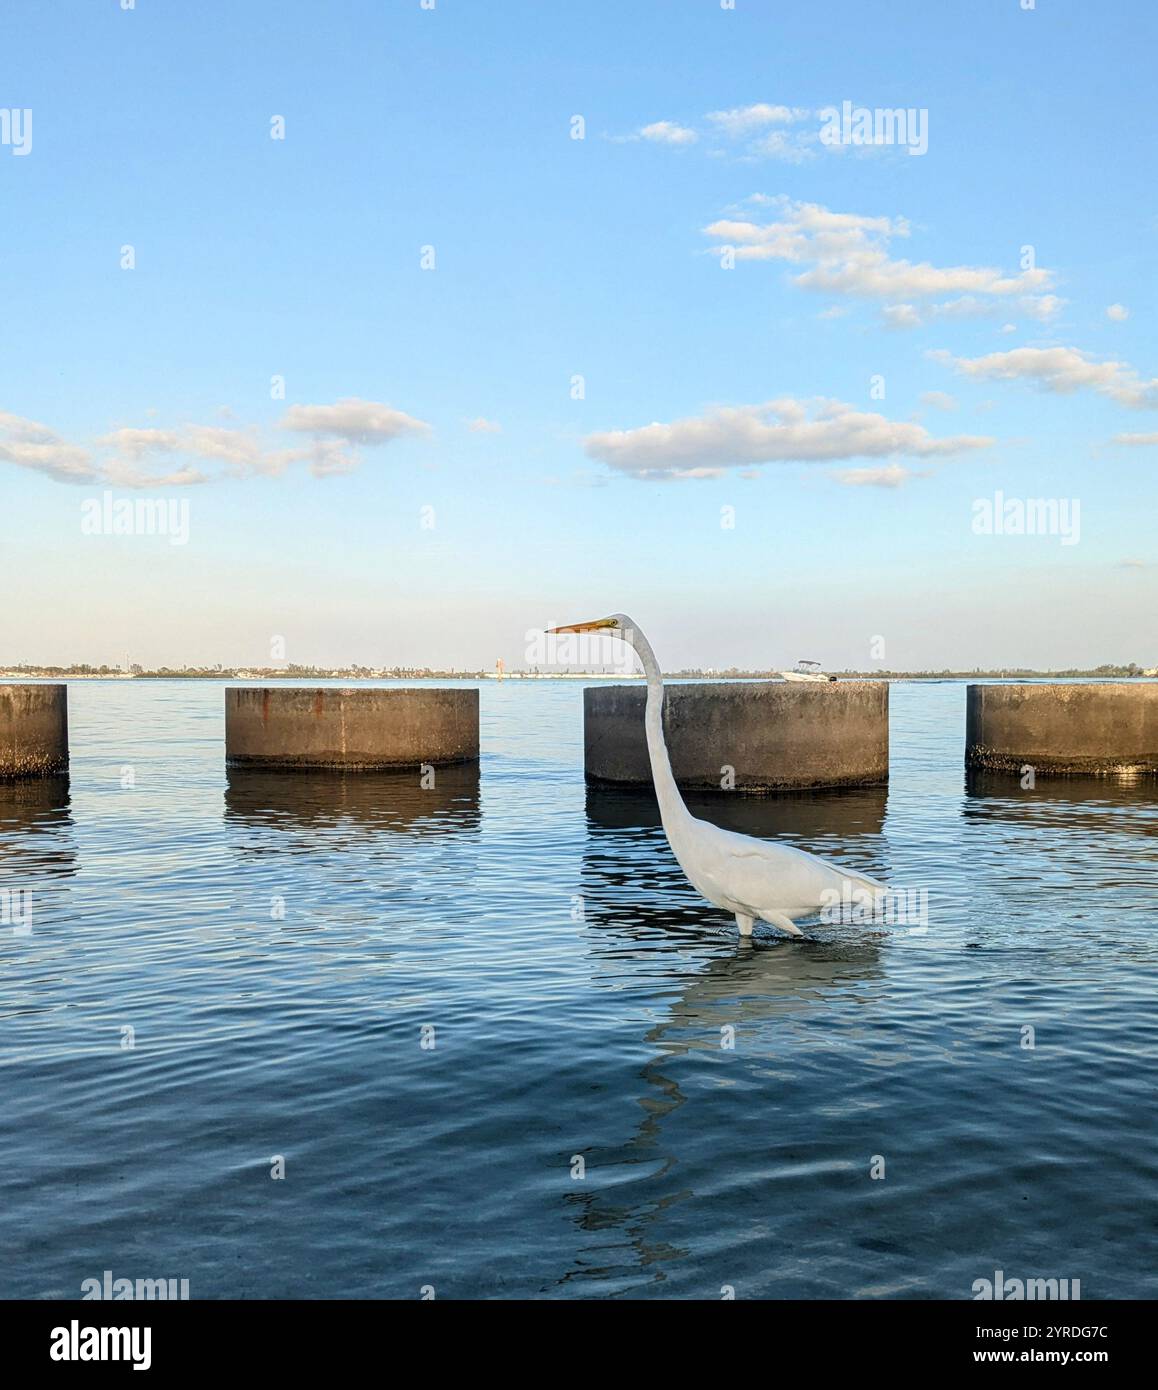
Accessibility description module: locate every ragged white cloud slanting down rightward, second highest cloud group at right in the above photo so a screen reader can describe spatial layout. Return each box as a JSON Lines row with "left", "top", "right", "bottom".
{"left": 705, "top": 197, "right": 1062, "bottom": 325}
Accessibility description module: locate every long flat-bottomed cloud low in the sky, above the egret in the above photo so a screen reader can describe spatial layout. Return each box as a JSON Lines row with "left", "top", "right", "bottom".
{"left": 584, "top": 398, "right": 994, "bottom": 480}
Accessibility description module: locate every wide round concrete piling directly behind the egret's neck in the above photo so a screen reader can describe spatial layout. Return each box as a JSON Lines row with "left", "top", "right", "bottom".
{"left": 582, "top": 681, "right": 888, "bottom": 792}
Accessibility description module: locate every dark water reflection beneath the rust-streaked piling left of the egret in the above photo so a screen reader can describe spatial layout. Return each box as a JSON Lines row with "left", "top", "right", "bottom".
{"left": 225, "top": 763, "right": 481, "bottom": 835}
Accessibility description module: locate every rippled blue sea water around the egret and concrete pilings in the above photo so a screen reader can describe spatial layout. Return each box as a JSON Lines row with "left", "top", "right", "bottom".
{"left": 0, "top": 681, "right": 1158, "bottom": 1298}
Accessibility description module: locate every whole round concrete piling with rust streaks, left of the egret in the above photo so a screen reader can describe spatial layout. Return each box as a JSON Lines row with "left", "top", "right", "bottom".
{"left": 225, "top": 687, "right": 478, "bottom": 771}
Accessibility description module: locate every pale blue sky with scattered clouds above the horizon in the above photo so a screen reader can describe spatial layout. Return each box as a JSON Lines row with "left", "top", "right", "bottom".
{"left": 0, "top": 0, "right": 1158, "bottom": 669}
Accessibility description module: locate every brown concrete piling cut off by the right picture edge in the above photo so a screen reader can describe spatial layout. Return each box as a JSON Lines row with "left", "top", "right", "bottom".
{"left": 965, "top": 682, "right": 1158, "bottom": 777}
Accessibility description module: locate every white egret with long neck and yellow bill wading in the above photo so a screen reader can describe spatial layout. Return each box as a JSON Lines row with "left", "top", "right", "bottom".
{"left": 549, "top": 613, "right": 887, "bottom": 937}
